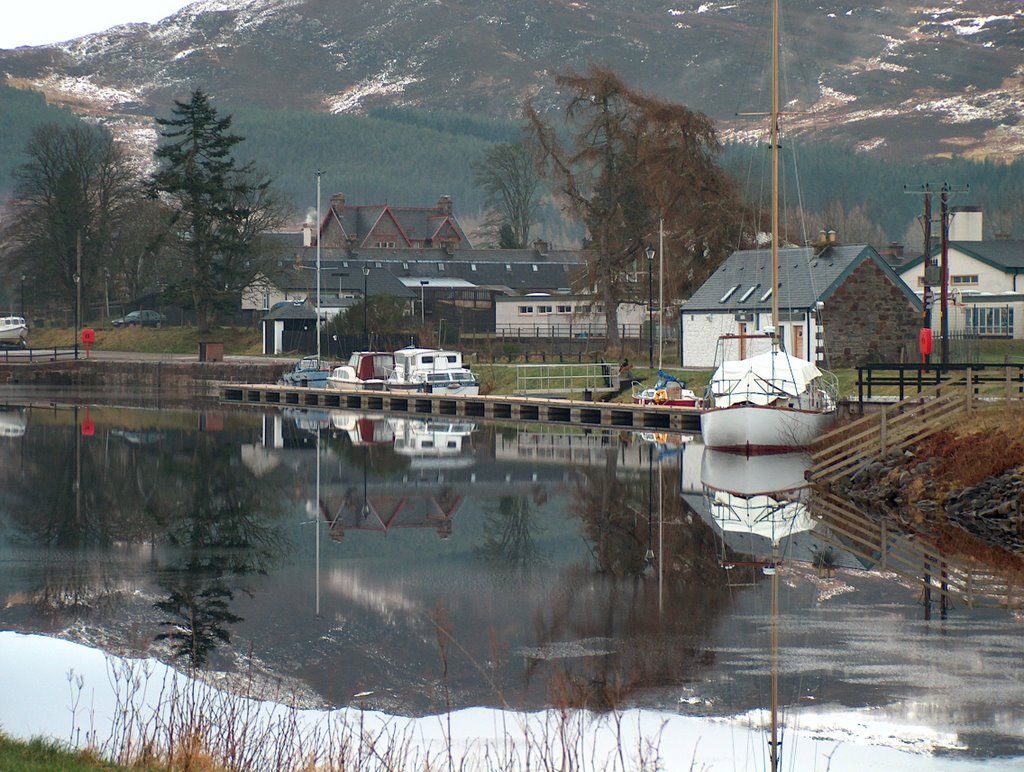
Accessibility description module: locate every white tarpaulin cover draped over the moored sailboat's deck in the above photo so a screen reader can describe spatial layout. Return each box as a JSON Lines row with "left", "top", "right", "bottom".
{"left": 709, "top": 349, "right": 821, "bottom": 408}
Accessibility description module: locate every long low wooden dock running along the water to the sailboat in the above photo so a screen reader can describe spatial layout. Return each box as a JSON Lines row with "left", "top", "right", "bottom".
{"left": 220, "top": 383, "right": 701, "bottom": 431}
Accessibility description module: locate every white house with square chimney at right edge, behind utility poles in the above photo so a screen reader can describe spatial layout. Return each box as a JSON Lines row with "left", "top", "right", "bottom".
{"left": 893, "top": 207, "right": 1024, "bottom": 339}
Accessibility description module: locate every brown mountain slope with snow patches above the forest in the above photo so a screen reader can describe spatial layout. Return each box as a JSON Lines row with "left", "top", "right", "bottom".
{"left": 0, "top": 0, "right": 1024, "bottom": 158}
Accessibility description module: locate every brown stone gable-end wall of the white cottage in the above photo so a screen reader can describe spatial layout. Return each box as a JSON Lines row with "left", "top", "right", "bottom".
{"left": 822, "top": 260, "right": 923, "bottom": 368}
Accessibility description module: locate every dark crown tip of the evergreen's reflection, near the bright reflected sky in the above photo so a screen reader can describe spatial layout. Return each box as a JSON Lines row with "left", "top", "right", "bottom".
{"left": 154, "top": 574, "right": 242, "bottom": 668}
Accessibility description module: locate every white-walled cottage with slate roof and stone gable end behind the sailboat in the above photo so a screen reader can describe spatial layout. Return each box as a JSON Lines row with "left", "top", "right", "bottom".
{"left": 679, "top": 243, "right": 923, "bottom": 368}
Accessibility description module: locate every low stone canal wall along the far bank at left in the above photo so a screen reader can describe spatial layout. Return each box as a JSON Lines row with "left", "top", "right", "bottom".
{"left": 0, "top": 359, "right": 287, "bottom": 396}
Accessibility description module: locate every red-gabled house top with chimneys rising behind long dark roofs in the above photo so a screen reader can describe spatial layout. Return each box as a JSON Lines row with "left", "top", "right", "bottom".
{"left": 306, "top": 194, "right": 472, "bottom": 254}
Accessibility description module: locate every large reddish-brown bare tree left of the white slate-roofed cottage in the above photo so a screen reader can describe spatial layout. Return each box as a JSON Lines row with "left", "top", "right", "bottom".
{"left": 525, "top": 67, "right": 740, "bottom": 346}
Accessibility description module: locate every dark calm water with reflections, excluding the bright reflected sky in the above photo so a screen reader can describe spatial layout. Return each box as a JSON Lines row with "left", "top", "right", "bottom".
{"left": 0, "top": 391, "right": 1024, "bottom": 759}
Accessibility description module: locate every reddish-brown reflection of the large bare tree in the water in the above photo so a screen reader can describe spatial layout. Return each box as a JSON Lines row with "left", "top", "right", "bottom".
{"left": 536, "top": 468, "right": 732, "bottom": 710}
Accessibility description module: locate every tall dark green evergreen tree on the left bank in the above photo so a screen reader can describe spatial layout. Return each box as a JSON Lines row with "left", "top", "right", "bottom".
{"left": 152, "top": 90, "right": 284, "bottom": 331}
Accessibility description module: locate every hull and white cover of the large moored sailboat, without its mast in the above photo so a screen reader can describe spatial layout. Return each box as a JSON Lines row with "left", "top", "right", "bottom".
{"left": 700, "top": 339, "right": 836, "bottom": 455}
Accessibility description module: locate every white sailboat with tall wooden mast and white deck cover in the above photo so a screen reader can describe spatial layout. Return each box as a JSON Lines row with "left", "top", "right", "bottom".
{"left": 700, "top": 0, "right": 836, "bottom": 455}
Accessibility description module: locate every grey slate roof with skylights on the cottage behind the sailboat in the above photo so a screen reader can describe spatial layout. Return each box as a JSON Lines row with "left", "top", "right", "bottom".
{"left": 682, "top": 244, "right": 920, "bottom": 313}
